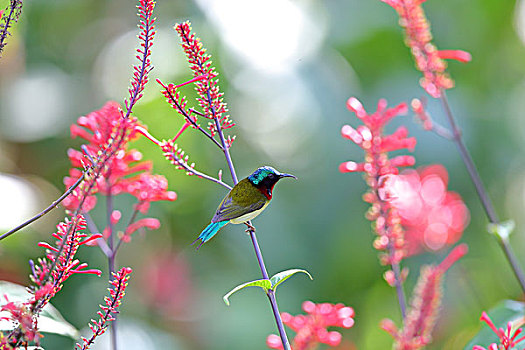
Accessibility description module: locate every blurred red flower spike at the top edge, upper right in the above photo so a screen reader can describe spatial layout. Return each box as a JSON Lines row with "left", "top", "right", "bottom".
{"left": 381, "top": 0, "right": 472, "bottom": 98}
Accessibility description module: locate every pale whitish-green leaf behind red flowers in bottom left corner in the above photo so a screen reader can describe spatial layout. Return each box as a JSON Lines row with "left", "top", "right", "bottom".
{"left": 0, "top": 281, "right": 79, "bottom": 339}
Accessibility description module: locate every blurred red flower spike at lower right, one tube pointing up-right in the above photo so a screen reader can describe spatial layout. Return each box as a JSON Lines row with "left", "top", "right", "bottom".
{"left": 381, "top": 244, "right": 468, "bottom": 350}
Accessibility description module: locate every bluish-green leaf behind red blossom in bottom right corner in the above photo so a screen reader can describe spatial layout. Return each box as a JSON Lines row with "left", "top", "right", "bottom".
{"left": 464, "top": 300, "right": 525, "bottom": 350}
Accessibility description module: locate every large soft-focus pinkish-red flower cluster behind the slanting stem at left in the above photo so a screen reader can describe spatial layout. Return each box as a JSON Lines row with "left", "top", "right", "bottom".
{"left": 63, "top": 102, "right": 177, "bottom": 241}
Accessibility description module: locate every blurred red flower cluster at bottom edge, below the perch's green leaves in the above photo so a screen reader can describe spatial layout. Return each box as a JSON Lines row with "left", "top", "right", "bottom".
{"left": 266, "top": 301, "right": 354, "bottom": 350}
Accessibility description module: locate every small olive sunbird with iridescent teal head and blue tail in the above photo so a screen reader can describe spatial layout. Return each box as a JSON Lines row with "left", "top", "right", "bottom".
{"left": 192, "top": 166, "right": 297, "bottom": 249}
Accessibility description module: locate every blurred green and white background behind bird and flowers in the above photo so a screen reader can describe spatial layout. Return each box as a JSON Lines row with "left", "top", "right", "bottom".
{"left": 0, "top": 0, "right": 525, "bottom": 350}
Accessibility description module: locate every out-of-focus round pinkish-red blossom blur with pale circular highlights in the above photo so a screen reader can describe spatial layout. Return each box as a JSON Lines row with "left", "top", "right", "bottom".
{"left": 385, "top": 165, "right": 469, "bottom": 255}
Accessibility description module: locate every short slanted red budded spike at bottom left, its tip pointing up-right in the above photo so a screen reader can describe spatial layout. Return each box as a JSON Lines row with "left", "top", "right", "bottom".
{"left": 75, "top": 267, "right": 133, "bottom": 350}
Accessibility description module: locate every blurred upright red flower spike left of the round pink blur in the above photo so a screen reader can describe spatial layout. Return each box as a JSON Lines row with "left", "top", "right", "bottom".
{"left": 339, "top": 97, "right": 416, "bottom": 265}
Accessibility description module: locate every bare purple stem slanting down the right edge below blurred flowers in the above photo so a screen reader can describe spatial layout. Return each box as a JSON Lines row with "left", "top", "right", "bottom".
{"left": 441, "top": 90, "right": 525, "bottom": 292}
